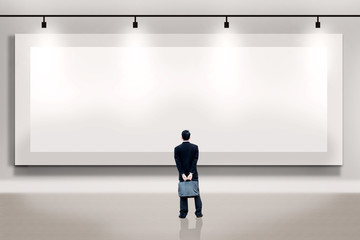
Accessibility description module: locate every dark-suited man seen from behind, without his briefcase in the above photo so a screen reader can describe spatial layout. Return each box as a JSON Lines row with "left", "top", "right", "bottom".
{"left": 174, "top": 130, "right": 203, "bottom": 218}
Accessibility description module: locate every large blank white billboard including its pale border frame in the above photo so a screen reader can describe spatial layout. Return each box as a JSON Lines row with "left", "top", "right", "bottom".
{"left": 16, "top": 34, "right": 342, "bottom": 165}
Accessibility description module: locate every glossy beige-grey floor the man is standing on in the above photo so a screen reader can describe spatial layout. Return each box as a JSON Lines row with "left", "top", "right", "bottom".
{"left": 0, "top": 193, "right": 360, "bottom": 240}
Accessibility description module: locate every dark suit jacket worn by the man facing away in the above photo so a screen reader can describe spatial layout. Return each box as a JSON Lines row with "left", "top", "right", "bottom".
{"left": 174, "top": 142, "right": 199, "bottom": 182}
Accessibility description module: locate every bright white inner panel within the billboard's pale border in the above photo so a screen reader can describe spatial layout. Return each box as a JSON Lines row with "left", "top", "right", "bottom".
{"left": 30, "top": 47, "right": 327, "bottom": 152}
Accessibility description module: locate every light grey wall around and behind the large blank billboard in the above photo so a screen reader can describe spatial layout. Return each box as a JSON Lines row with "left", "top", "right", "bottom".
{"left": 0, "top": 0, "right": 360, "bottom": 191}
